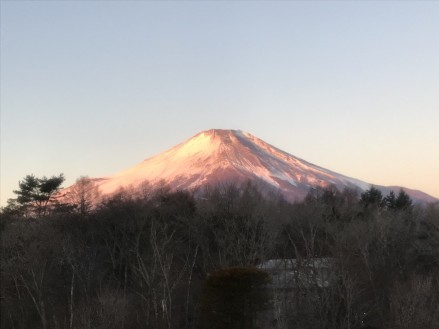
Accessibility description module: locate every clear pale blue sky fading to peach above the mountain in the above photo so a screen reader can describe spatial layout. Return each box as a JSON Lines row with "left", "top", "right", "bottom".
{"left": 0, "top": 1, "right": 439, "bottom": 205}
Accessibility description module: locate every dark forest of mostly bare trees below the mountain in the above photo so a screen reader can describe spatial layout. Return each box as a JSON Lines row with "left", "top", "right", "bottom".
{"left": 0, "top": 175, "right": 439, "bottom": 329}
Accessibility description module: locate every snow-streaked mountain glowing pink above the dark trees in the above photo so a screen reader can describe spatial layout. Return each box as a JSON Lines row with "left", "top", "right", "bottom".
{"left": 73, "top": 129, "right": 436, "bottom": 202}
